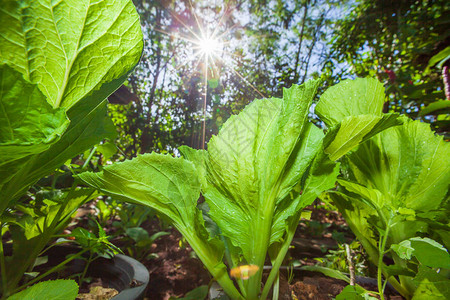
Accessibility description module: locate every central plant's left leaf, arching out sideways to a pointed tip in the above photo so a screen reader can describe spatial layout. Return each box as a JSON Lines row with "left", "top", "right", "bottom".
{"left": 78, "top": 153, "right": 237, "bottom": 293}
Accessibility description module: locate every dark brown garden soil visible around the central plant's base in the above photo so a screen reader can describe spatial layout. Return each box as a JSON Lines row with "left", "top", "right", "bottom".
{"left": 70, "top": 206, "right": 403, "bottom": 300}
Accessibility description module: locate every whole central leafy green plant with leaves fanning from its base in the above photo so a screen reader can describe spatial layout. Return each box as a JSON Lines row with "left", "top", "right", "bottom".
{"left": 79, "top": 79, "right": 400, "bottom": 299}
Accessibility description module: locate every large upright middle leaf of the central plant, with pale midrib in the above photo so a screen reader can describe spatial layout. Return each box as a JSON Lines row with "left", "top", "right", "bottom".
{"left": 181, "top": 82, "right": 324, "bottom": 263}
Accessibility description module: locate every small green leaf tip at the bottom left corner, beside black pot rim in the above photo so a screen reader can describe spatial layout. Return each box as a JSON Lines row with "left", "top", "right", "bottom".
{"left": 8, "top": 280, "right": 78, "bottom": 300}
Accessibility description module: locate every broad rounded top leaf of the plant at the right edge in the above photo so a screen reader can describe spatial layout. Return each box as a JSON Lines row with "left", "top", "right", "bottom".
{"left": 347, "top": 121, "right": 450, "bottom": 211}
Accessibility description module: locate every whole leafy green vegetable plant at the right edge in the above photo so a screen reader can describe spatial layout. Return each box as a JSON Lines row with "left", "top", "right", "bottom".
{"left": 328, "top": 120, "right": 450, "bottom": 299}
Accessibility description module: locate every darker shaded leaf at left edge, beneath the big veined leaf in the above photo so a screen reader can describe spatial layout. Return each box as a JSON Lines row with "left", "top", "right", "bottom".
{"left": 0, "top": 65, "right": 69, "bottom": 168}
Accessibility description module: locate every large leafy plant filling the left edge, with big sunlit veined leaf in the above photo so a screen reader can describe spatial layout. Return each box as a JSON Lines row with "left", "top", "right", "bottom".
{"left": 0, "top": 0, "right": 143, "bottom": 297}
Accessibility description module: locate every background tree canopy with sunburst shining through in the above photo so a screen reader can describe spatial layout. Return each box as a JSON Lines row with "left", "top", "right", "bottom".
{"left": 106, "top": 0, "right": 450, "bottom": 157}
